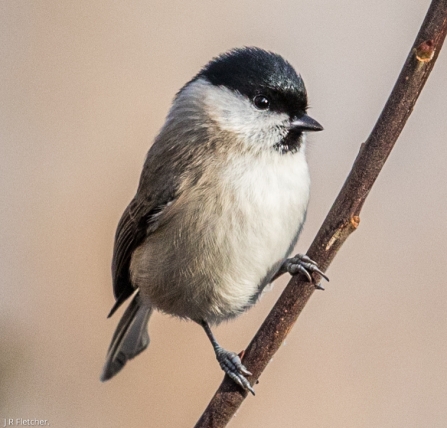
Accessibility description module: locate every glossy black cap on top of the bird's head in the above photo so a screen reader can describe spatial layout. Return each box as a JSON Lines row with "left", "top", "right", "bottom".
{"left": 193, "top": 47, "right": 307, "bottom": 116}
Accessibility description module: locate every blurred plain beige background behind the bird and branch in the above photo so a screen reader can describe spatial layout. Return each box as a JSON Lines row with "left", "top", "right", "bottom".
{"left": 0, "top": 0, "right": 447, "bottom": 428}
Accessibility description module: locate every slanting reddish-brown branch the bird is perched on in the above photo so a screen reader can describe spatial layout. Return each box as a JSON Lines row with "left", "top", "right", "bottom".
{"left": 195, "top": 0, "right": 447, "bottom": 428}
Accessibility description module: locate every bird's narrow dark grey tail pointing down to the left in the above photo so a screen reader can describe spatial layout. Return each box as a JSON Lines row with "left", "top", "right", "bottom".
{"left": 101, "top": 292, "right": 153, "bottom": 382}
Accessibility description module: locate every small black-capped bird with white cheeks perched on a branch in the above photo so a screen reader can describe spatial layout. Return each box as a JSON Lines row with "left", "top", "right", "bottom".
{"left": 101, "top": 47, "right": 327, "bottom": 394}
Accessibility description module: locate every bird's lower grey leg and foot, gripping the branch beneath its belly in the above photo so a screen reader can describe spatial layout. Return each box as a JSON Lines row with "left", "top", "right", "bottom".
{"left": 201, "top": 320, "right": 255, "bottom": 395}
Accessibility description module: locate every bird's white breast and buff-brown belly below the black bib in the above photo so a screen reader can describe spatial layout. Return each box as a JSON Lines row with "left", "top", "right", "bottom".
{"left": 131, "top": 152, "right": 310, "bottom": 323}
